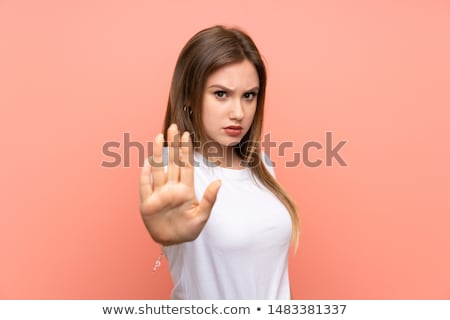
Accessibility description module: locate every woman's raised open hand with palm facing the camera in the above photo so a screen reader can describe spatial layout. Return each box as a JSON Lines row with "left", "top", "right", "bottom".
{"left": 140, "top": 124, "right": 221, "bottom": 246}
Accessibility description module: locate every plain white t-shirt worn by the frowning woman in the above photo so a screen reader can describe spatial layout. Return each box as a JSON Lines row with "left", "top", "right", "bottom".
{"left": 164, "top": 153, "right": 292, "bottom": 300}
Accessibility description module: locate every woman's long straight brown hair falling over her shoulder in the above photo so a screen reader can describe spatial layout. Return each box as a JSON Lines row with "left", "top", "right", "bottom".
{"left": 163, "top": 26, "right": 300, "bottom": 247}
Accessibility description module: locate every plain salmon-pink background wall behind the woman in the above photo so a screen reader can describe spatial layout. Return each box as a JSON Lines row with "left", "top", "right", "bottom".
{"left": 0, "top": 0, "right": 450, "bottom": 299}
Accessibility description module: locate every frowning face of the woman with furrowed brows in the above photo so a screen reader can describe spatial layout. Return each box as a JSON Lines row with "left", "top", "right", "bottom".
{"left": 202, "top": 60, "right": 259, "bottom": 146}
